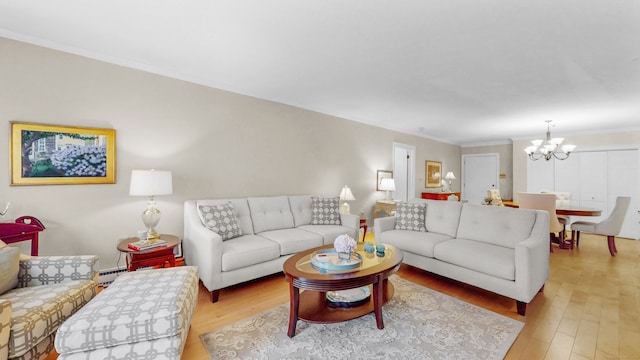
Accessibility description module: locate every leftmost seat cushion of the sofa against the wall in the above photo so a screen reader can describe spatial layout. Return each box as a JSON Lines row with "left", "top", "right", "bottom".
{"left": 222, "top": 235, "right": 280, "bottom": 271}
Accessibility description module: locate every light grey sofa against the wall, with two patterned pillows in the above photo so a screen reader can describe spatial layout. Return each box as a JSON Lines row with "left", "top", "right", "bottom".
{"left": 182, "top": 195, "right": 360, "bottom": 302}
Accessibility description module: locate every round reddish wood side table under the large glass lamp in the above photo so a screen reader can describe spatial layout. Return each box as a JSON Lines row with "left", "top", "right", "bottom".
{"left": 118, "top": 234, "right": 180, "bottom": 271}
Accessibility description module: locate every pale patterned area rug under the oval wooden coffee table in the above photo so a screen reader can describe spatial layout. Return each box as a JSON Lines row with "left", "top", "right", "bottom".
{"left": 201, "top": 275, "right": 524, "bottom": 360}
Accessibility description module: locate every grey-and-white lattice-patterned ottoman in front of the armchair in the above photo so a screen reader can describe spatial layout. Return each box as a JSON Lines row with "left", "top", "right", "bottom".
{"left": 55, "top": 266, "right": 198, "bottom": 360}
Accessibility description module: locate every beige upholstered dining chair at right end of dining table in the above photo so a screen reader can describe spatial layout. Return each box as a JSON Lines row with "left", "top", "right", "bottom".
{"left": 571, "top": 196, "right": 631, "bottom": 256}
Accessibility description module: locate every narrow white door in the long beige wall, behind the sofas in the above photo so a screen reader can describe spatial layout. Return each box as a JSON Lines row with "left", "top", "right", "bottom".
{"left": 393, "top": 143, "right": 416, "bottom": 201}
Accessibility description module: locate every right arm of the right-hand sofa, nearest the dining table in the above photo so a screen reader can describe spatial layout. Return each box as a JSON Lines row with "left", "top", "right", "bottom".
{"left": 515, "top": 210, "right": 549, "bottom": 303}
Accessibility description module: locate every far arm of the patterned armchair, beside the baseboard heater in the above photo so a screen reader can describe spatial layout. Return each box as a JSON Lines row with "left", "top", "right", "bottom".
{"left": 18, "top": 255, "right": 100, "bottom": 288}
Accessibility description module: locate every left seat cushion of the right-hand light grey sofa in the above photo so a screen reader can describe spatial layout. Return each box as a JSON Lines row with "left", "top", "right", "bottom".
{"left": 376, "top": 230, "right": 451, "bottom": 258}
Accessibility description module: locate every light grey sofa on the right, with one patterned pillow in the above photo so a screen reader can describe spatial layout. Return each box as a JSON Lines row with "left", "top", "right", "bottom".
{"left": 374, "top": 199, "right": 549, "bottom": 316}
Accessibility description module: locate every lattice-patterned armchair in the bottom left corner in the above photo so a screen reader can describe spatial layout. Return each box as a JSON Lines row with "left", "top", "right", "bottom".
{"left": 0, "top": 245, "right": 99, "bottom": 360}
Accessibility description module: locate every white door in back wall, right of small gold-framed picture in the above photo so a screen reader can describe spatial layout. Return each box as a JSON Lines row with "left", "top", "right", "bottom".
{"left": 461, "top": 153, "right": 500, "bottom": 204}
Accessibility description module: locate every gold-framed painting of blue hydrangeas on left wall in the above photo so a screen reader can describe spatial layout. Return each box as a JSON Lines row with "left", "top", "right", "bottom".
{"left": 11, "top": 122, "right": 116, "bottom": 185}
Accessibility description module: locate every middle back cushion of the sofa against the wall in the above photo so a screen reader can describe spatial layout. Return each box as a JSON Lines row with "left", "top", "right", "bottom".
{"left": 248, "top": 196, "right": 293, "bottom": 234}
